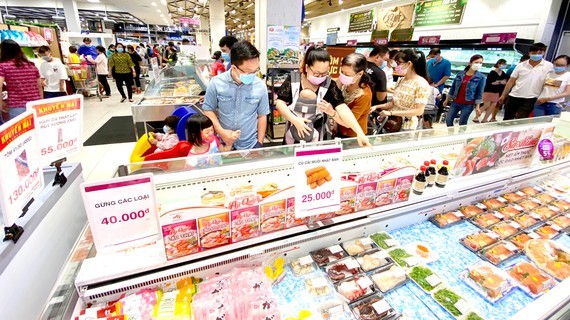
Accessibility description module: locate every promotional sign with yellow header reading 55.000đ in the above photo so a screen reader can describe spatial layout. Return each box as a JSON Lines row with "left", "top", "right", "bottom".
{"left": 26, "top": 94, "right": 83, "bottom": 165}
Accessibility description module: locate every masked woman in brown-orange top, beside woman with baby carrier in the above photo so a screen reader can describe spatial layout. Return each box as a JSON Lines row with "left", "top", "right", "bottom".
{"left": 337, "top": 53, "right": 374, "bottom": 138}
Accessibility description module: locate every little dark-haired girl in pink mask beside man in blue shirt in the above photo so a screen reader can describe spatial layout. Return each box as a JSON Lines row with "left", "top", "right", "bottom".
{"left": 186, "top": 114, "right": 240, "bottom": 168}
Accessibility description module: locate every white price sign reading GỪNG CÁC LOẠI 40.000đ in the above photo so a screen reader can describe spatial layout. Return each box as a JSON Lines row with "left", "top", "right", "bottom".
{"left": 81, "top": 174, "right": 161, "bottom": 252}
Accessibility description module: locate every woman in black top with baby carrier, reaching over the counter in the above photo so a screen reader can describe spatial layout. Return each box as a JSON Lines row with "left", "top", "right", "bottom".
{"left": 275, "top": 47, "right": 370, "bottom": 146}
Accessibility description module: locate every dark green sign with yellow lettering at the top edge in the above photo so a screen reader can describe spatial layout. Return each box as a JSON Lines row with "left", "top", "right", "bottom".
{"left": 414, "top": 0, "right": 467, "bottom": 27}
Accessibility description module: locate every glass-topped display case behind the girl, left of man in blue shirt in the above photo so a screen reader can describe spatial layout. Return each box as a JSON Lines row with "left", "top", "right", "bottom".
{"left": 131, "top": 60, "right": 209, "bottom": 139}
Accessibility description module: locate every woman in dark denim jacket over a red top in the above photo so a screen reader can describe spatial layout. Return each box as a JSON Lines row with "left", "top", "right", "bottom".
{"left": 443, "top": 54, "right": 486, "bottom": 127}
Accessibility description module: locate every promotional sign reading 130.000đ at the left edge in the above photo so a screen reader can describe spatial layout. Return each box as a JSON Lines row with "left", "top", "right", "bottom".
{"left": 0, "top": 111, "right": 44, "bottom": 226}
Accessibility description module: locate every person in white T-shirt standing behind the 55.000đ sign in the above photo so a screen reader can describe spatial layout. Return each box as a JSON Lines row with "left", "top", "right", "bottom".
{"left": 38, "top": 46, "right": 67, "bottom": 99}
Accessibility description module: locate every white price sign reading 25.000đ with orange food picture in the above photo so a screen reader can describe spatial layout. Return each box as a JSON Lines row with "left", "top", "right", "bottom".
{"left": 295, "top": 145, "right": 342, "bottom": 218}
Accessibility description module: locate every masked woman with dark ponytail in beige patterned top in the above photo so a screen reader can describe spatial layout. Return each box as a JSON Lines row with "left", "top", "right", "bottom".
{"left": 370, "top": 49, "right": 431, "bottom": 131}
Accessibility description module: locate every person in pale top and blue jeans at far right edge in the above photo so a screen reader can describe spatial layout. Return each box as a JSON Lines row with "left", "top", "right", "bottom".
{"left": 533, "top": 55, "right": 570, "bottom": 117}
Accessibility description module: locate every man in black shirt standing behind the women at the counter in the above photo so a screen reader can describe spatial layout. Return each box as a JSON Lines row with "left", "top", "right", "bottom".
{"left": 366, "top": 45, "right": 390, "bottom": 106}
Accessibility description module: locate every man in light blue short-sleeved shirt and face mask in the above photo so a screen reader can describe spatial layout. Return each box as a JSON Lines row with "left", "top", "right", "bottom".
{"left": 202, "top": 41, "right": 269, "bottom": 150}
